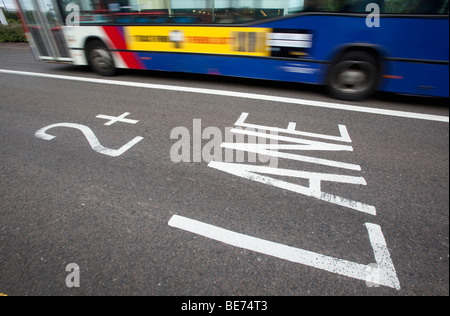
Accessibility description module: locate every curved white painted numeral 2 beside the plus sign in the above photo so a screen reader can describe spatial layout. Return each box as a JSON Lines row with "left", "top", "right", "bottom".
{"left": 35, "top": 123, "right": 144, "bottom": 157}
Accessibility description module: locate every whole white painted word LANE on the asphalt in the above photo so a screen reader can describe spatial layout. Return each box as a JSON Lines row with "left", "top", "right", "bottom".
{"left": 169, "top": 113, "right": 401, "bottom": 290}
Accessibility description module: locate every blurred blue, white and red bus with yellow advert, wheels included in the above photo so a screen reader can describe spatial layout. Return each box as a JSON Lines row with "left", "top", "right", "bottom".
{"left": 17, "top": 0, "right": 449, "bottom": 101}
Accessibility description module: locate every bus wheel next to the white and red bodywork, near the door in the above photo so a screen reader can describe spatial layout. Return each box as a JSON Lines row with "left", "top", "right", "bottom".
{"left": 86, "top": 40, "right": 117, "bottom": 77}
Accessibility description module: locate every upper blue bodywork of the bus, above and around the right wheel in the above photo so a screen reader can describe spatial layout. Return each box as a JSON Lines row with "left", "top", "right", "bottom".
{"left": 255, "top": 14, "right": 449, "bottom": 62}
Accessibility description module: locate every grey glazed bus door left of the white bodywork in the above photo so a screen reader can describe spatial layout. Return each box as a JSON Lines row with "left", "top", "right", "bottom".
{"left": 18, "top": 0, "right": 72, "bottom": 62}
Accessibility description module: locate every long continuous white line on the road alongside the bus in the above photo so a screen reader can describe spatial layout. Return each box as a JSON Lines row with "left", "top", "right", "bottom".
{"left": 0, "top": 69, "right": 449, "bottom": 123}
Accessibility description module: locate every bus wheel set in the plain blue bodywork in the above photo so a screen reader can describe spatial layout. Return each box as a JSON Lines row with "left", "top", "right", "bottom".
{"left": 327, "top": 51, "right": 380, "bottom": 101}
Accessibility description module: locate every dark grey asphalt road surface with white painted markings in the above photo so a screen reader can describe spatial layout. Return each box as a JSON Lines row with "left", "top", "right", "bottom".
{"left": 0, "top": 44, "right": 449, "bottom": 296}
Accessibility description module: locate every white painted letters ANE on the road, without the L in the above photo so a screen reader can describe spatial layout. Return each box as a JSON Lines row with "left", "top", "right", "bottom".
{"left": 208, "top": 113, "right": 377, "bottom": 216}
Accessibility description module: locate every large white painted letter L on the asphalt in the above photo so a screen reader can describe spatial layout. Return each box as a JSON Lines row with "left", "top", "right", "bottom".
{"left": 169, "top": 215, "right": 401, "bottom": 290}
